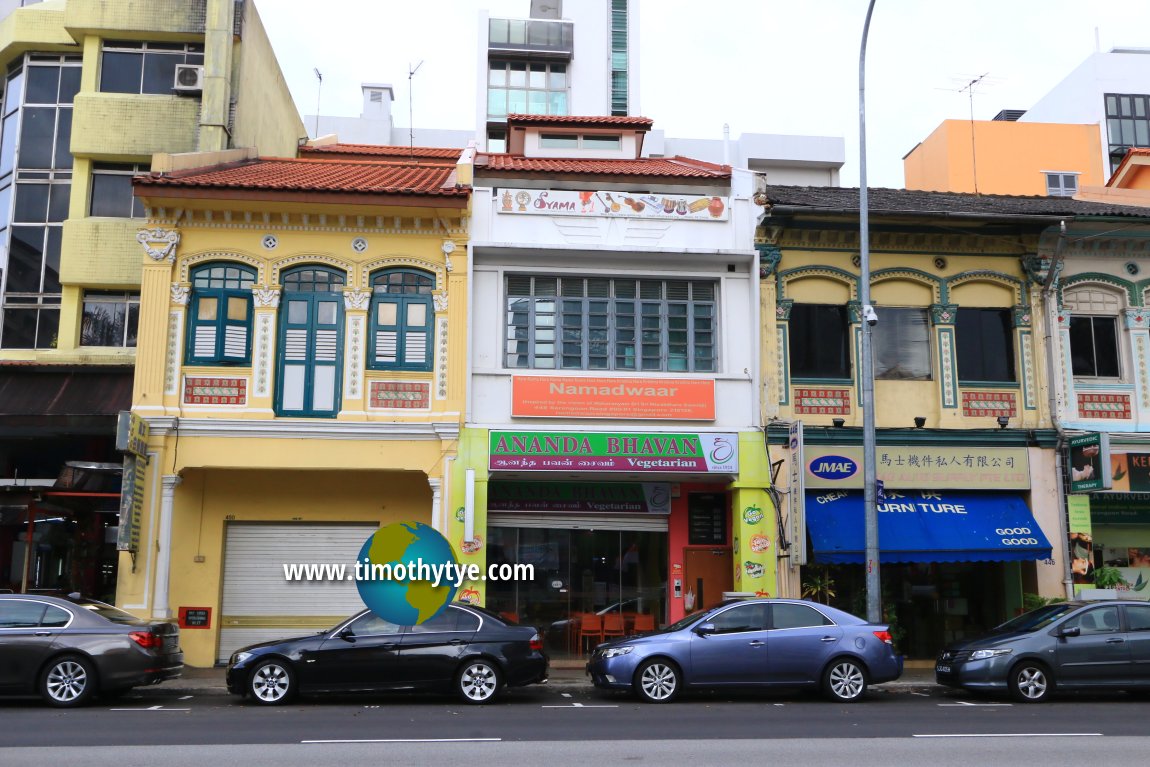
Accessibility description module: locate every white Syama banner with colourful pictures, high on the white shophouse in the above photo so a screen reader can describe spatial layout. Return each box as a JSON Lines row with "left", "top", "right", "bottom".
{"left": 496, "top": 189, "right": 730, "bottom": 221}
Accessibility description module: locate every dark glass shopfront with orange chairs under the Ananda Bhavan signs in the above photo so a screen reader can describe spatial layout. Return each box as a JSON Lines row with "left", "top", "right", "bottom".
{"left": 488, "top": 527, "right": 667, "bottom": 658}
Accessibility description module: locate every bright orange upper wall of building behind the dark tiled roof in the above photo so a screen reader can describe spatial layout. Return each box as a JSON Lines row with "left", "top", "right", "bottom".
{"left": 903, "top": 120, "right": 1106, "bottom": 195}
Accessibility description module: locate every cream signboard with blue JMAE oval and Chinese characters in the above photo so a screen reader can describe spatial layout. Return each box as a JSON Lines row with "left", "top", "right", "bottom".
{"left": 804, "top": 445, "right": 1030, "bottom": 490}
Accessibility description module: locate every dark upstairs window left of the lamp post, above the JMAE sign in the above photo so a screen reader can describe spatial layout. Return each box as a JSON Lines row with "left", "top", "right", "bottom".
{"left": 787, "top": 304, "right": 851, "bottom": 379}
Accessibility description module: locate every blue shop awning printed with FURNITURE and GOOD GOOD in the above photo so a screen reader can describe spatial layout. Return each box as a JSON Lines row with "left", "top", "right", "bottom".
{"left": 806, "top": 490, "right": 1050, "bottom": 565}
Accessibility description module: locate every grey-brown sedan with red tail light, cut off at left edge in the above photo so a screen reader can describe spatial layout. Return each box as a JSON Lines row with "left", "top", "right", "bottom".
{"left": 0, "top": 593, "right": 184, "bottom": 707}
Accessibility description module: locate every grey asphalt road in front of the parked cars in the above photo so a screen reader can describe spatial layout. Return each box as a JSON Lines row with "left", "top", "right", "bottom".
{"left": 0, "top": 688, "right": 1150, "bottom": 754}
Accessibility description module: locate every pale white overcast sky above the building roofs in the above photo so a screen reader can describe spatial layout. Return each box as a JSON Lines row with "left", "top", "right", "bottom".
{"left": 255, "top": 0, "right": 1150, "bottom": 187}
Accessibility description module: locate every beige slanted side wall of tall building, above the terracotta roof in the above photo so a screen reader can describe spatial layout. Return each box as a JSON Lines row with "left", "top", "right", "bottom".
{"left": 231, "top": 2, "right": 307, "bottom": 158}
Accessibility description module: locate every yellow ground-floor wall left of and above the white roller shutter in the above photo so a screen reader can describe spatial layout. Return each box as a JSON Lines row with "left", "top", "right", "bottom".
{"left": 162, "top": 469, "right": 431, "bottom": 666}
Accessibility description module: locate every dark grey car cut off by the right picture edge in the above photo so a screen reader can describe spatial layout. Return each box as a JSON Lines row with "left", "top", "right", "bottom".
{"left": 935, "top": 600, "right": 1150, "bottom": 703}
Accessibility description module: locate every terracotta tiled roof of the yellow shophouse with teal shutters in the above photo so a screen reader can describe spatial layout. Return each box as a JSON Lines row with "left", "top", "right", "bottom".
{"left": 135, "top": 158, "right": 470, "bottom": 197}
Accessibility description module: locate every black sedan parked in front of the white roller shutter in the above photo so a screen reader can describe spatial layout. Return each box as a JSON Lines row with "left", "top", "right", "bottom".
{"left": 228, "top": 604, "right": 547, "bottom": 705}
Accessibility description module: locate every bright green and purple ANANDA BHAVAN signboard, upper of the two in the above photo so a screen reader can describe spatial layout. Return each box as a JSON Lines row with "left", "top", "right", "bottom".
{"left": 489, "top": 431, "right": 738, "bottom": 474}
